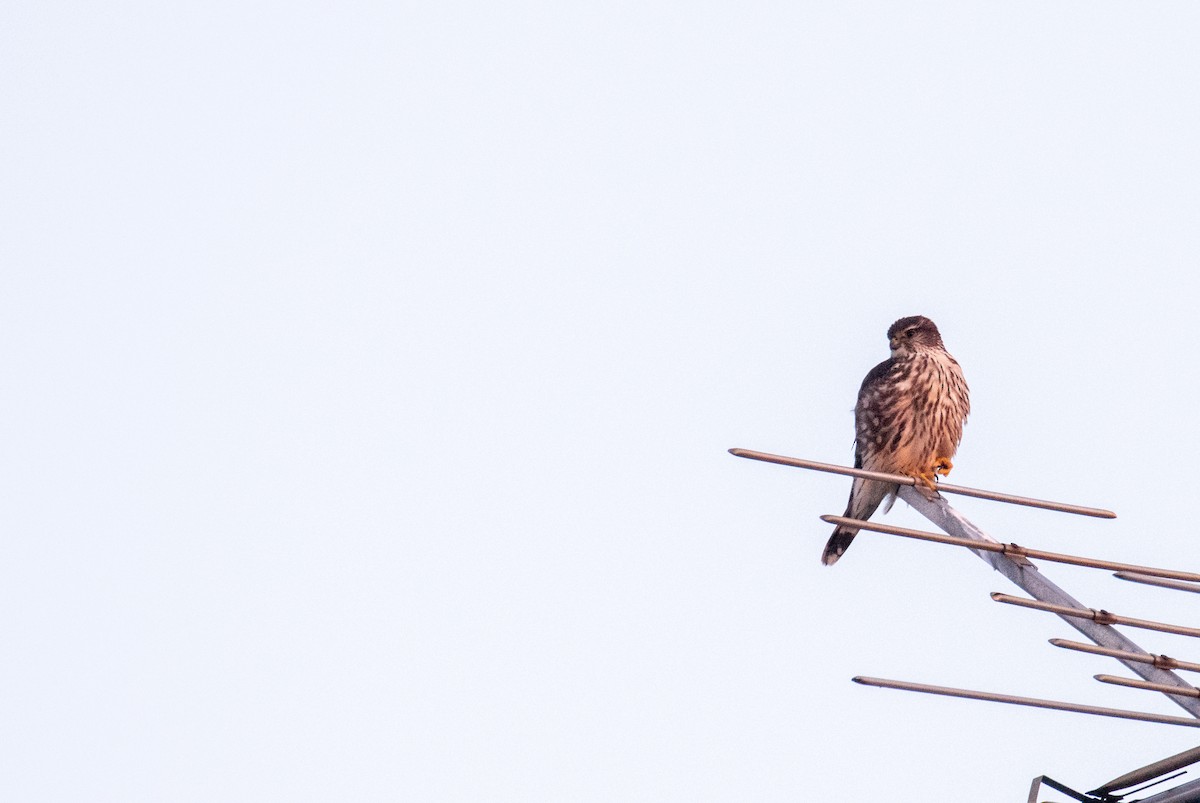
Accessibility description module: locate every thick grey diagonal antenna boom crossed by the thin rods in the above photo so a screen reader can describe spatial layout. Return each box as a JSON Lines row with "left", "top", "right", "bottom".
{"left": 900, "top": 486, "right": 1200, "bottom": 719}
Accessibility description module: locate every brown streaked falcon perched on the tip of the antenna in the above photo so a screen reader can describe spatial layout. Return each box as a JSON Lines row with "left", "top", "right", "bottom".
{"left": 821, "top": 316, "right": 971, "bottom": 565}
